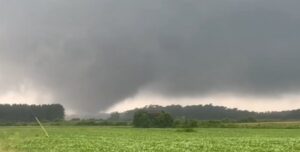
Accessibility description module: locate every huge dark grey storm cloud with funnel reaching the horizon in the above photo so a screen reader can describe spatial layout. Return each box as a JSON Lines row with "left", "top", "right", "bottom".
{"left": 0, "top": 0, "right": 300, "bottom": 112}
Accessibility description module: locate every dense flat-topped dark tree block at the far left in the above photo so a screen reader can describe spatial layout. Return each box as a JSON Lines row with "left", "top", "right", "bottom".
{"left": 0, "top": 104, "right": 65, "bottom": 123}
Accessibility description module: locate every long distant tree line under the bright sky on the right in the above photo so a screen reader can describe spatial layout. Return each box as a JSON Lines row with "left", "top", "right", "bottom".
{"left": 119, "top": 104, "right": 300, "bottom": 121}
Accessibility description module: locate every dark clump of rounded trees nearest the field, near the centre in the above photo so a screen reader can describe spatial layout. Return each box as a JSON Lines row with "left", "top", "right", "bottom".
{"left": 133, "top": 110, "right": 174, "bottom": 128}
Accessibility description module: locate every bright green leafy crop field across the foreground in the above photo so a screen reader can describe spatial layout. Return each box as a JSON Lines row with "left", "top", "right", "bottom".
{"left": 0, "top": 126, "right": 300, "bottom": 152}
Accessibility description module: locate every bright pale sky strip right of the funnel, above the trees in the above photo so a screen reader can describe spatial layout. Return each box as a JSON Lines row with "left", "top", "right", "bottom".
{"left": 106, "top": 93, "right": 300, "bottom": 112}
